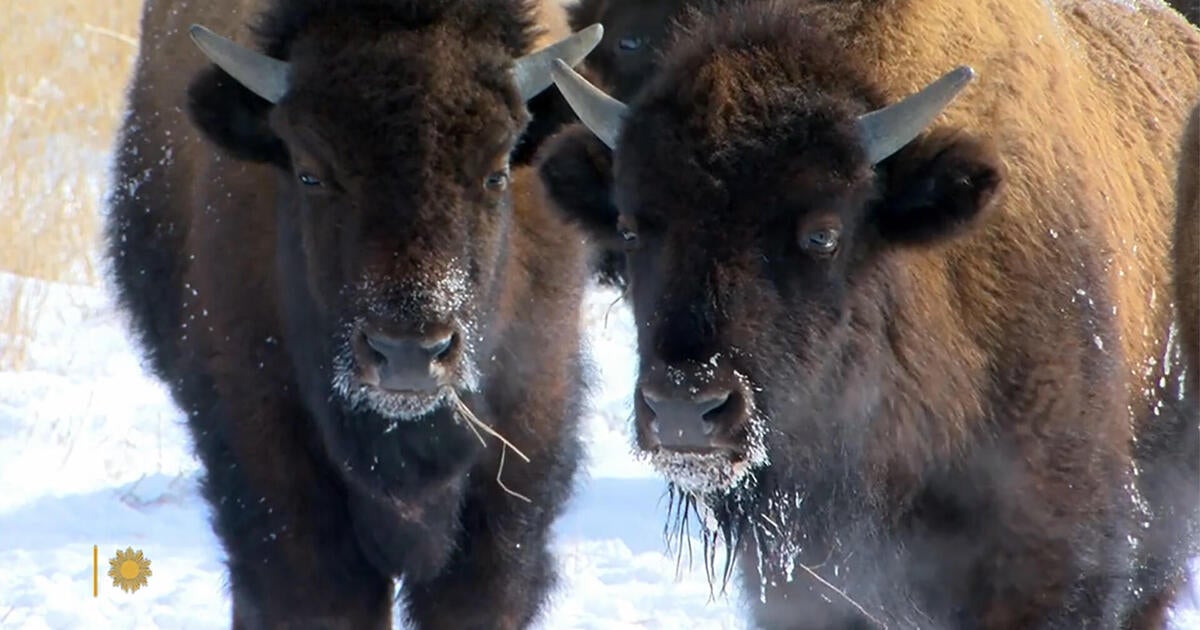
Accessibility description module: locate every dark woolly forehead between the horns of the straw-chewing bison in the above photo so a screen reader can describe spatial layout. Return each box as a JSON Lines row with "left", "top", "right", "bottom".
{"left": 281, "top": 26, "right": 529, "bottom": 161}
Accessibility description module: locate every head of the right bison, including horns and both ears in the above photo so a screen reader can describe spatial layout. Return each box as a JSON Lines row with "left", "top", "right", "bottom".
{"left": 541, "top": 61, "right": 1000, "bottom": 496}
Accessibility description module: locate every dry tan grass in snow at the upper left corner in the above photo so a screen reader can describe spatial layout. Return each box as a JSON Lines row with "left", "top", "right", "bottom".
{"left": 0, "top": 0, "right": 142, "bottom": 370}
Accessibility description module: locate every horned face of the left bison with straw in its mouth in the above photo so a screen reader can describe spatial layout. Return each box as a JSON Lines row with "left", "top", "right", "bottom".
{"left": 184, "top": 18, "right": 601, "bottom": 420}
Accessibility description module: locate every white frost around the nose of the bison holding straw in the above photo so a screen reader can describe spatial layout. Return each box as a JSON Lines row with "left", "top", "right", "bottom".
{"left": 332, "top": 259, "right": 481, "bottom": 421}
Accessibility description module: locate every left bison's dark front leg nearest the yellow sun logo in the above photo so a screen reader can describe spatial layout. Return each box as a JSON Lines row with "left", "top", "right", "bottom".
{"left": 190, "top": 391, "right": 391, "bottom": 630}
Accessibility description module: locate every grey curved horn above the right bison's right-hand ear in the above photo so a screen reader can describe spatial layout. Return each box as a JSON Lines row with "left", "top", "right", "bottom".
{"left": 858, "top": 66, "right": 974, "bottom": 164}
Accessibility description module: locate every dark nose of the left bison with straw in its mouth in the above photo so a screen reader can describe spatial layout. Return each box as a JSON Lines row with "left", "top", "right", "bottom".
{"left": 359, "top": 332, "right": 457, "bottom": 391}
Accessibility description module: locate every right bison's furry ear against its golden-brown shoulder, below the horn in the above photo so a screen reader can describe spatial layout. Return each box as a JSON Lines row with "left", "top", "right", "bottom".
{"left": 875, "top": 131, "right": 1004, "bottom": 245}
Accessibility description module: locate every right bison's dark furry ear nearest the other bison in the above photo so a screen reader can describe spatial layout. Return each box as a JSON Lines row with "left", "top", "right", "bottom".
{"left": 536, "top": 124, "right": 625, "bottom": 287}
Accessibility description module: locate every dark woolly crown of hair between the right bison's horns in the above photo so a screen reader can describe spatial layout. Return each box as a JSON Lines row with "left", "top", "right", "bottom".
{"left": 616, "top": 39, "right": 884, "bottom": 208}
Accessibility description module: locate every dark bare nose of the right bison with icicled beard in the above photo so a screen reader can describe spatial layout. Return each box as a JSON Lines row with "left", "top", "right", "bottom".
{"left": 642, "top": 390, "right": 733, "bottom": 450}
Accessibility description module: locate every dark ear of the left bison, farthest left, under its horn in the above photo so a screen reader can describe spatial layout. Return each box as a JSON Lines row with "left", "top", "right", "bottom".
{"left": 187, "top": 66, "right": 288, "bottom": 168}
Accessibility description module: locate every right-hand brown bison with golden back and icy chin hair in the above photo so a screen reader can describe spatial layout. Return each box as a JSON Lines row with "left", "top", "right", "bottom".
{"left": 540, "top": 0, "right": 1200, "bottom": 629}
